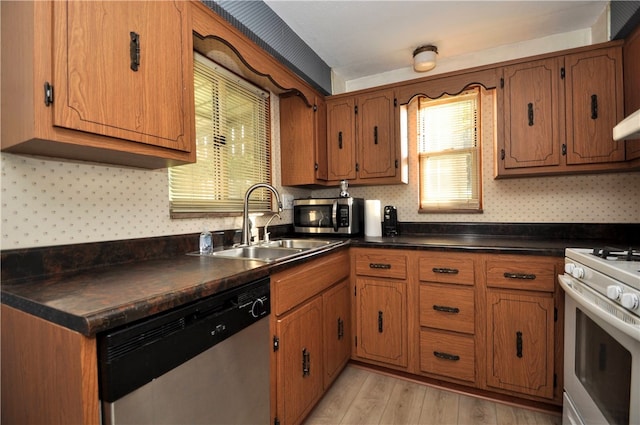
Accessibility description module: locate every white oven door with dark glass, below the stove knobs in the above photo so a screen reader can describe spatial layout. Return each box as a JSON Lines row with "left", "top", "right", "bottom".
{"left": 558, "top": 275, "right": 640, "bottom": 424}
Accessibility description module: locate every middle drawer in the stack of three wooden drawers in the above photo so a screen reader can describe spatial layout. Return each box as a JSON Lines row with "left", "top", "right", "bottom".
{"left": 420, "top": 284, "right": 475, "bottom": 334}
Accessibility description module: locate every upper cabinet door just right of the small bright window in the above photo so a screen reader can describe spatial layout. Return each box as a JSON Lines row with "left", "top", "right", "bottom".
{"left": 500, "top": 58, "right": 563, "bottom": 169}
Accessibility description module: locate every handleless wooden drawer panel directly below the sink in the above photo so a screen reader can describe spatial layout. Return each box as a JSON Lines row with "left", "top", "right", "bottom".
{"left": 271, "top": 251, "right": 349, "bottom": 316}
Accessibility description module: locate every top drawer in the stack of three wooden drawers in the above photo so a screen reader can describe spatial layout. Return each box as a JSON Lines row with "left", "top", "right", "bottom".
{"left": 419, "top": 256, "right": 474, "bottom": 285}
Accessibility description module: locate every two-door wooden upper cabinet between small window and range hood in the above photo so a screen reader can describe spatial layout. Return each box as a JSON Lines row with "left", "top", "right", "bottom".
{"left": 495, "top": 42, "right": 630, "bottom": 177}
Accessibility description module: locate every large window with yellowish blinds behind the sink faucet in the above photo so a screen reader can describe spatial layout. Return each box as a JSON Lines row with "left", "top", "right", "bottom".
{"left": 169, "top": 53, "right": 271, "bottom": 217}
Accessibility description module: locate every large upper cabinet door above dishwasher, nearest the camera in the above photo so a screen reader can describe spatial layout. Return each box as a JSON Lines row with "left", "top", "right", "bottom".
{"left": 52, "top": 0, "right": 193, "bottom": 152}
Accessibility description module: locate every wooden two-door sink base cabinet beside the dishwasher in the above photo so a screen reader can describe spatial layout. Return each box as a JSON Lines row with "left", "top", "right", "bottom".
{"left": 271, "top": 250, "right": 352, "bottom": 425}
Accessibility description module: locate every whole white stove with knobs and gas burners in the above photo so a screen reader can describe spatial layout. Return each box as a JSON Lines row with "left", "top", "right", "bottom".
{"left": 558, "top": 248, "right": 640, "bottom": 425}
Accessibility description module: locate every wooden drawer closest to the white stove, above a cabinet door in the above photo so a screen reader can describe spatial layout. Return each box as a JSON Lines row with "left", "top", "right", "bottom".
{"left": 486, "top": 259, "right": 556, "bottom": 292}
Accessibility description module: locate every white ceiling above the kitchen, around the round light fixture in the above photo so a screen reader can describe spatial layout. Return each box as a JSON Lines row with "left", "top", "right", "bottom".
{"left": 265, "top": 0, "right": 609, "bottom": 80}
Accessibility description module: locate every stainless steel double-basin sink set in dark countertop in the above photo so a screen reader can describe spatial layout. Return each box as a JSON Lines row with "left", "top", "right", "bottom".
{"left": 188, "top": 239, "right": 340, "bottom": 263}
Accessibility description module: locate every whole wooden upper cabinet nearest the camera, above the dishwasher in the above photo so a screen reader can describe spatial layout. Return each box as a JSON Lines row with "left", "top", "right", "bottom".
{"left": 2, "top": 0, "right": 196, "bottom": 168}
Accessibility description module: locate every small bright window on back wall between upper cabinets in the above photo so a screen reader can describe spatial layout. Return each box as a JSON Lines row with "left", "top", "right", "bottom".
{"left": 417, "top": 88, "right": 482, "bottom": 212}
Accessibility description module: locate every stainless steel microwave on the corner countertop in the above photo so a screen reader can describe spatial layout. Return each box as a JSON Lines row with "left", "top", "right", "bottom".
{"left": 293, "top": 198, "right": 364, "bottom": 235}
